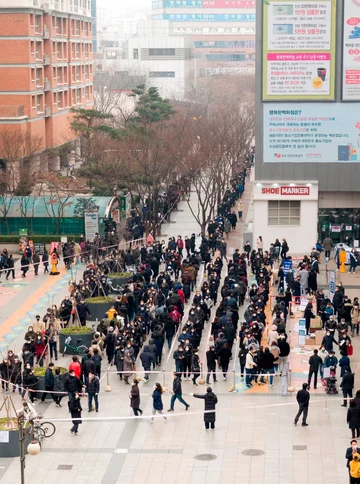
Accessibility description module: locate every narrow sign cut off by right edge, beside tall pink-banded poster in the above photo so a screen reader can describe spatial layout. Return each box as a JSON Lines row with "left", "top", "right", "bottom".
{"left": 342, "top": 0, "right": 360, "bottom": 101}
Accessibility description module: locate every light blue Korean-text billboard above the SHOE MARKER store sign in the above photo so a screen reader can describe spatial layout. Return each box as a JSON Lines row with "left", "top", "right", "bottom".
{"left": 263, "top": 103, "right": 360, "bottom": 163}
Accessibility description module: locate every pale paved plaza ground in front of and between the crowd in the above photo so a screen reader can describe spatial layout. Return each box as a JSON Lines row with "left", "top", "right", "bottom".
{"left": 0, "top": 178, "right": 360, "bottom": 484}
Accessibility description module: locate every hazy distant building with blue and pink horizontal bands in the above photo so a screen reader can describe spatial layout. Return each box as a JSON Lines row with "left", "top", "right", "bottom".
{"left": 152, "top": 0, "right": 256, "bottom": 75}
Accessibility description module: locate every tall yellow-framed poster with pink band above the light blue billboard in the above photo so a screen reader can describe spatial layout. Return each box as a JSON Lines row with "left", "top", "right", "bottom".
{"left": 263, "top": 0, "right": 336, "bottom": 100}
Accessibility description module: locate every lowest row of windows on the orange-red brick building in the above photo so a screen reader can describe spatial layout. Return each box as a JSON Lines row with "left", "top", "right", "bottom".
{"left": 31, "top": 86, "right": 93, "bottom": 114}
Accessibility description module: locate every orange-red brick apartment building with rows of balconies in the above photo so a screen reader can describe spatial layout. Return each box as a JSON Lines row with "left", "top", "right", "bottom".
{"left": 0, "top": 0, "right": 93, "bottom": 149}
